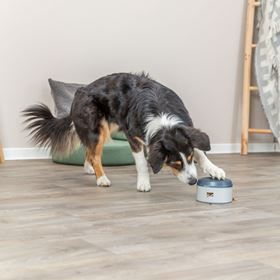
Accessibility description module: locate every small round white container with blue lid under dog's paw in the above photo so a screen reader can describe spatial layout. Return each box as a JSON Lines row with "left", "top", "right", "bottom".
{"left": 196, "top": 177, "right": 232, "bottom": 203}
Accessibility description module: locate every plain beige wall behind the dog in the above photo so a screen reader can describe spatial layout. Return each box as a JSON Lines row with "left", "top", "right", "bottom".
{"left": 0, "top": 0, "right": 271, "bottom": 151}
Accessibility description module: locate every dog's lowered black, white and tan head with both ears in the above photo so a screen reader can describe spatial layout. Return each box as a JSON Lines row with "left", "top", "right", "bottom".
{"left": 149, "top": 125, "right": 210, "bottom": 185}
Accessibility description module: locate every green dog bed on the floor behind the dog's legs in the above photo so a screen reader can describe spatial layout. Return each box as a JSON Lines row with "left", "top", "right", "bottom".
{"left": 52, "top": 139, "right": 134, "bottom": 166}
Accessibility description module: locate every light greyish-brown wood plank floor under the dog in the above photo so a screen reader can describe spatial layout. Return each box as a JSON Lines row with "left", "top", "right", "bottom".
{"left": 0, "top": 154, "right": 280, "bottom": 280}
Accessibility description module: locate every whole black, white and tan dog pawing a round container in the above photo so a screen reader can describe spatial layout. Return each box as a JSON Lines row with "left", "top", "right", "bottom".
{"left": 23, "top": 73, "right": 225, "bottom": 192}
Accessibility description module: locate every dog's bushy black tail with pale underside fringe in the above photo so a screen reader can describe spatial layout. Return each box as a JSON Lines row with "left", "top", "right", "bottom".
{"left": 22, "top": 104, "right": 80, "bottom": 157}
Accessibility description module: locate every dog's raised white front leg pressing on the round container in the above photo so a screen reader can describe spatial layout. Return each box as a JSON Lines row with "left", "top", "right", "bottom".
{"left": 194, "top": 148, "right": 226, "bottom": 180}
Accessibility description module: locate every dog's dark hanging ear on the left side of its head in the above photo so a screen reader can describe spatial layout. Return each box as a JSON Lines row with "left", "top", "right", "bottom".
{"left": 148, "top": 142, "right": 166, "bottom": 174}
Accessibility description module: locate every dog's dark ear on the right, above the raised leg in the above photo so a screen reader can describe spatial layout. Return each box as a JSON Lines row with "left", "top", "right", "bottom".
{"left": 179, "top": 127, "right": 211, "bottom": 151}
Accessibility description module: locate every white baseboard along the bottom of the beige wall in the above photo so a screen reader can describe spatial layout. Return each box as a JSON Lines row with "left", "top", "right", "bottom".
{"left": 4, "top": 143, "right": 280, "bottom": 160}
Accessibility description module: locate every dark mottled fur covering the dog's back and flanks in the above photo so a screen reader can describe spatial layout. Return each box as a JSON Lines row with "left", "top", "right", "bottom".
{"left": 70, "top": 73, "right": 193, "bottom": 143}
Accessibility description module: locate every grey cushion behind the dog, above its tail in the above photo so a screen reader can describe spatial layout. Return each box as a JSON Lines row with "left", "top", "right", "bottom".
{"left": 48, "top": 79, "right": 85, "bottom": 118}
